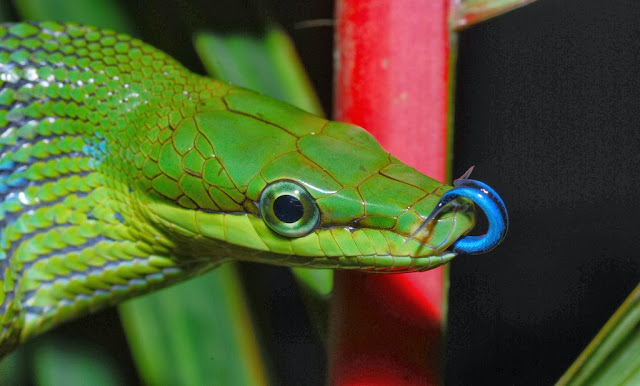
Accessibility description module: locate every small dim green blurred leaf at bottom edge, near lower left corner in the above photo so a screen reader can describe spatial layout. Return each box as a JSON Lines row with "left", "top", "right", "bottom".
{"left": 34, "top": 339, "right": 125, "bottom": 386}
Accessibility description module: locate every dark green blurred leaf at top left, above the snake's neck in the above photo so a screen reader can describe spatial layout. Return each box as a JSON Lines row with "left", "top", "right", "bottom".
{"left": 14, "top": 0, "right": 133, "bottom": 34}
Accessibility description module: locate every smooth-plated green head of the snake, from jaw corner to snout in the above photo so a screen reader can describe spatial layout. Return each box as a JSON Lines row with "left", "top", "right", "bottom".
{"left": 146, "top": 88, "right": 506, "bottom": 272}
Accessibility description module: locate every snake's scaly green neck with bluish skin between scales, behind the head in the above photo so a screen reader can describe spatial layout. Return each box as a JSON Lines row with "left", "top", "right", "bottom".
{"left": 0, "top": 23, "right": 232, "bottom": 354}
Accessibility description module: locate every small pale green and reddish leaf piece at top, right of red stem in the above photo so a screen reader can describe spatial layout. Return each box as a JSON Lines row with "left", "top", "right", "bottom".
{"left": 454, "top": 0, "right": 535, "bottom": 29}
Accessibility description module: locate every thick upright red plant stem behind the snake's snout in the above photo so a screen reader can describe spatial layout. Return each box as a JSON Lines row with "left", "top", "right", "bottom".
{"left": 329, "top": 0, "right": 452, "bottom": 385}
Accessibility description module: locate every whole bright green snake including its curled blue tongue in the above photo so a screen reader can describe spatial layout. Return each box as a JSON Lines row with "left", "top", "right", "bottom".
{"left": 0, "top": 22, "right": 506, "bottom": 354}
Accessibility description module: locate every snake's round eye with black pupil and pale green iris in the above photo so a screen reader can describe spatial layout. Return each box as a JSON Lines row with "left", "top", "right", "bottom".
{"left": 260, "top": 180, "right": 320, "bottom": 237}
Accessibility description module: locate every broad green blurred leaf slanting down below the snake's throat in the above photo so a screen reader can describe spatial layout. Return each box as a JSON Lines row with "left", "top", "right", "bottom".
{"left": 120, "top": 264, "right": 267, "bottom": 385}
